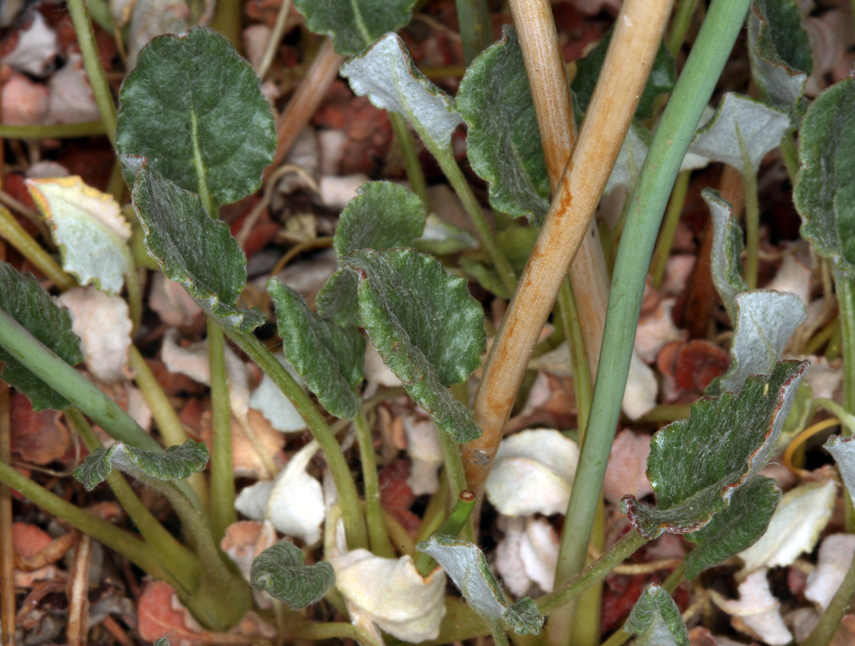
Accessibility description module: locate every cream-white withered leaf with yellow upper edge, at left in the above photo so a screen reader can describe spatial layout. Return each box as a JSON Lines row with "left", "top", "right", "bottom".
{"left": 27, "top": 176, "right": 133, "bottom": 294}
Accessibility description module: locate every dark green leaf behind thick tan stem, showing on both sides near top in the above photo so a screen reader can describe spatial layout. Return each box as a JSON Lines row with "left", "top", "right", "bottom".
{"left": 570, "top": 27, "right": 677, "bottom": 120}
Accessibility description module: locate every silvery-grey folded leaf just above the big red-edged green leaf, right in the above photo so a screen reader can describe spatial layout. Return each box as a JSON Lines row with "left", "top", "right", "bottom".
{"left": 706, "top": 289, "right": 807, "bottom": 395}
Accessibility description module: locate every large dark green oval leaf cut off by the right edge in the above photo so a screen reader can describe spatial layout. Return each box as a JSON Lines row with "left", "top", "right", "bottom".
{"left": 793, "top": 78, "right": 855, "bottom": 273}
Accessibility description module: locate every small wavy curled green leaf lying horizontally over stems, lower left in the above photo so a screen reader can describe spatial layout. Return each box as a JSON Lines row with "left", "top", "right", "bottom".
{"left": 74, "top": 440, "right": 209, "bottom": 491}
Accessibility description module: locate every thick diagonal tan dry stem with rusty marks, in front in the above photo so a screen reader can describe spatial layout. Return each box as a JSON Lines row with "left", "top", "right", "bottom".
{"left": 463, "top": 0, "right": 672, "bottom": 494}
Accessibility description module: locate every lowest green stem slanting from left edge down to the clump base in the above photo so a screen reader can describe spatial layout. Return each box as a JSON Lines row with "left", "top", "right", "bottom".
{"left": 0, "top": 463, "right": 179, "bottom": 594}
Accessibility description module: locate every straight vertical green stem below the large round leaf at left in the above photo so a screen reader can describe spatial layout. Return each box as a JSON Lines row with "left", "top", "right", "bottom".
{"left": 207, "top": 317, "right": 237, "bottom": 543}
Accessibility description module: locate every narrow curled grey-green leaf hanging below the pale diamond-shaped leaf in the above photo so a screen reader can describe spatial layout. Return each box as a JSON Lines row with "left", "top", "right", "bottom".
{"left": 701, "top": 189, "right": 748, "bottom": 321}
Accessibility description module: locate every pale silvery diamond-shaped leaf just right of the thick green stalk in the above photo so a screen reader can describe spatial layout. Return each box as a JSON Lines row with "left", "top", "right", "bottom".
{"left": 689, "top": 92, "right": 790, "bottom": 175}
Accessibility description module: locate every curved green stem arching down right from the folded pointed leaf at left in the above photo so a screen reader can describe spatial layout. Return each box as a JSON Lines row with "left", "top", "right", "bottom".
{"left": 224, "top": 328, "right": 368, "bottom": 550}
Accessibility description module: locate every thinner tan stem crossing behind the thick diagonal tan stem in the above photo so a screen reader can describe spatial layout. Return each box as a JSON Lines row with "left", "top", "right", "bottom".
{"left": 510, "top": 0, "right": 609, "bottom": 380}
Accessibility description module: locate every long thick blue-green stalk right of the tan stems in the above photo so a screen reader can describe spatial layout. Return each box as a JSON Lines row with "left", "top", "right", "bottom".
{"left": 563, "top": 0, "right": 749, "bottom": 592}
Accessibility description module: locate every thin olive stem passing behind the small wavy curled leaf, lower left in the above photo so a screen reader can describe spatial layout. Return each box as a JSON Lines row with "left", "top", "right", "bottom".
{"left": 65, "top": 406, "right": 201, "bottom": 590}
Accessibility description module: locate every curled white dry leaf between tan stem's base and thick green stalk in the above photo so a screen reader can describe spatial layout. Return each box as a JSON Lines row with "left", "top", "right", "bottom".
{"left": 486, "top": 428, "right": 579, "bottom": 516}
